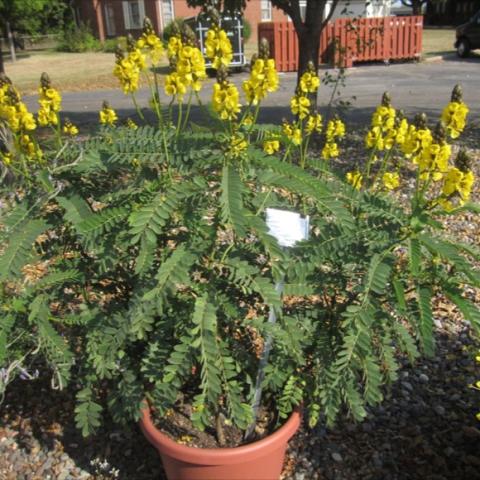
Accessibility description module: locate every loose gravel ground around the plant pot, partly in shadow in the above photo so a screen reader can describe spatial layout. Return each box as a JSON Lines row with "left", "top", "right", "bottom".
{"left": 0, "top": 126, "right": 480, "bottom": 480}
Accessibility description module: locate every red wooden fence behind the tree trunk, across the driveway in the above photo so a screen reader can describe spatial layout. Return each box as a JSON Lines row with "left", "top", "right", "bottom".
{"left": 258, "top": 16, "right": 423, "bottom": 72}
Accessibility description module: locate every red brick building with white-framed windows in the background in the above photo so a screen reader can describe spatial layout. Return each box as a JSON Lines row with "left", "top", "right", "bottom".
{"left": 75, "top": 0, "right": 288, "bottom": 41}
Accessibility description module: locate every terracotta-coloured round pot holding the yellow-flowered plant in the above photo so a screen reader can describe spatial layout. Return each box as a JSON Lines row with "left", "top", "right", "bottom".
{"left": 139, "top": 406, "right": 301, "bottom": 480}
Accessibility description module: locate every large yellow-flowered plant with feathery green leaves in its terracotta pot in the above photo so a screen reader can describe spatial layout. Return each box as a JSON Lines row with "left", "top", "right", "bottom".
{"left": 0, "top": 13, "right": 479, "bottom": 479}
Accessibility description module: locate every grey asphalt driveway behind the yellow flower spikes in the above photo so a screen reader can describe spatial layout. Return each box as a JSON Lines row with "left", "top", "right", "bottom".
{"left": 25, "top": 57, "right": 480, "bottom": 125}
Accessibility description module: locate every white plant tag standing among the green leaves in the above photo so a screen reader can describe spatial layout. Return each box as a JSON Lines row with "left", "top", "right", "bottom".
{"left": 266, "top": 208, "right": 310, "bottom": 247}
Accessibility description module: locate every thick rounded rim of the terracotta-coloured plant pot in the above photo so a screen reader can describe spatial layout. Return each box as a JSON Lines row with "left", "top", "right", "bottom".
{"left": 139, "top": 402, "right": 301, "bottom": 465}
